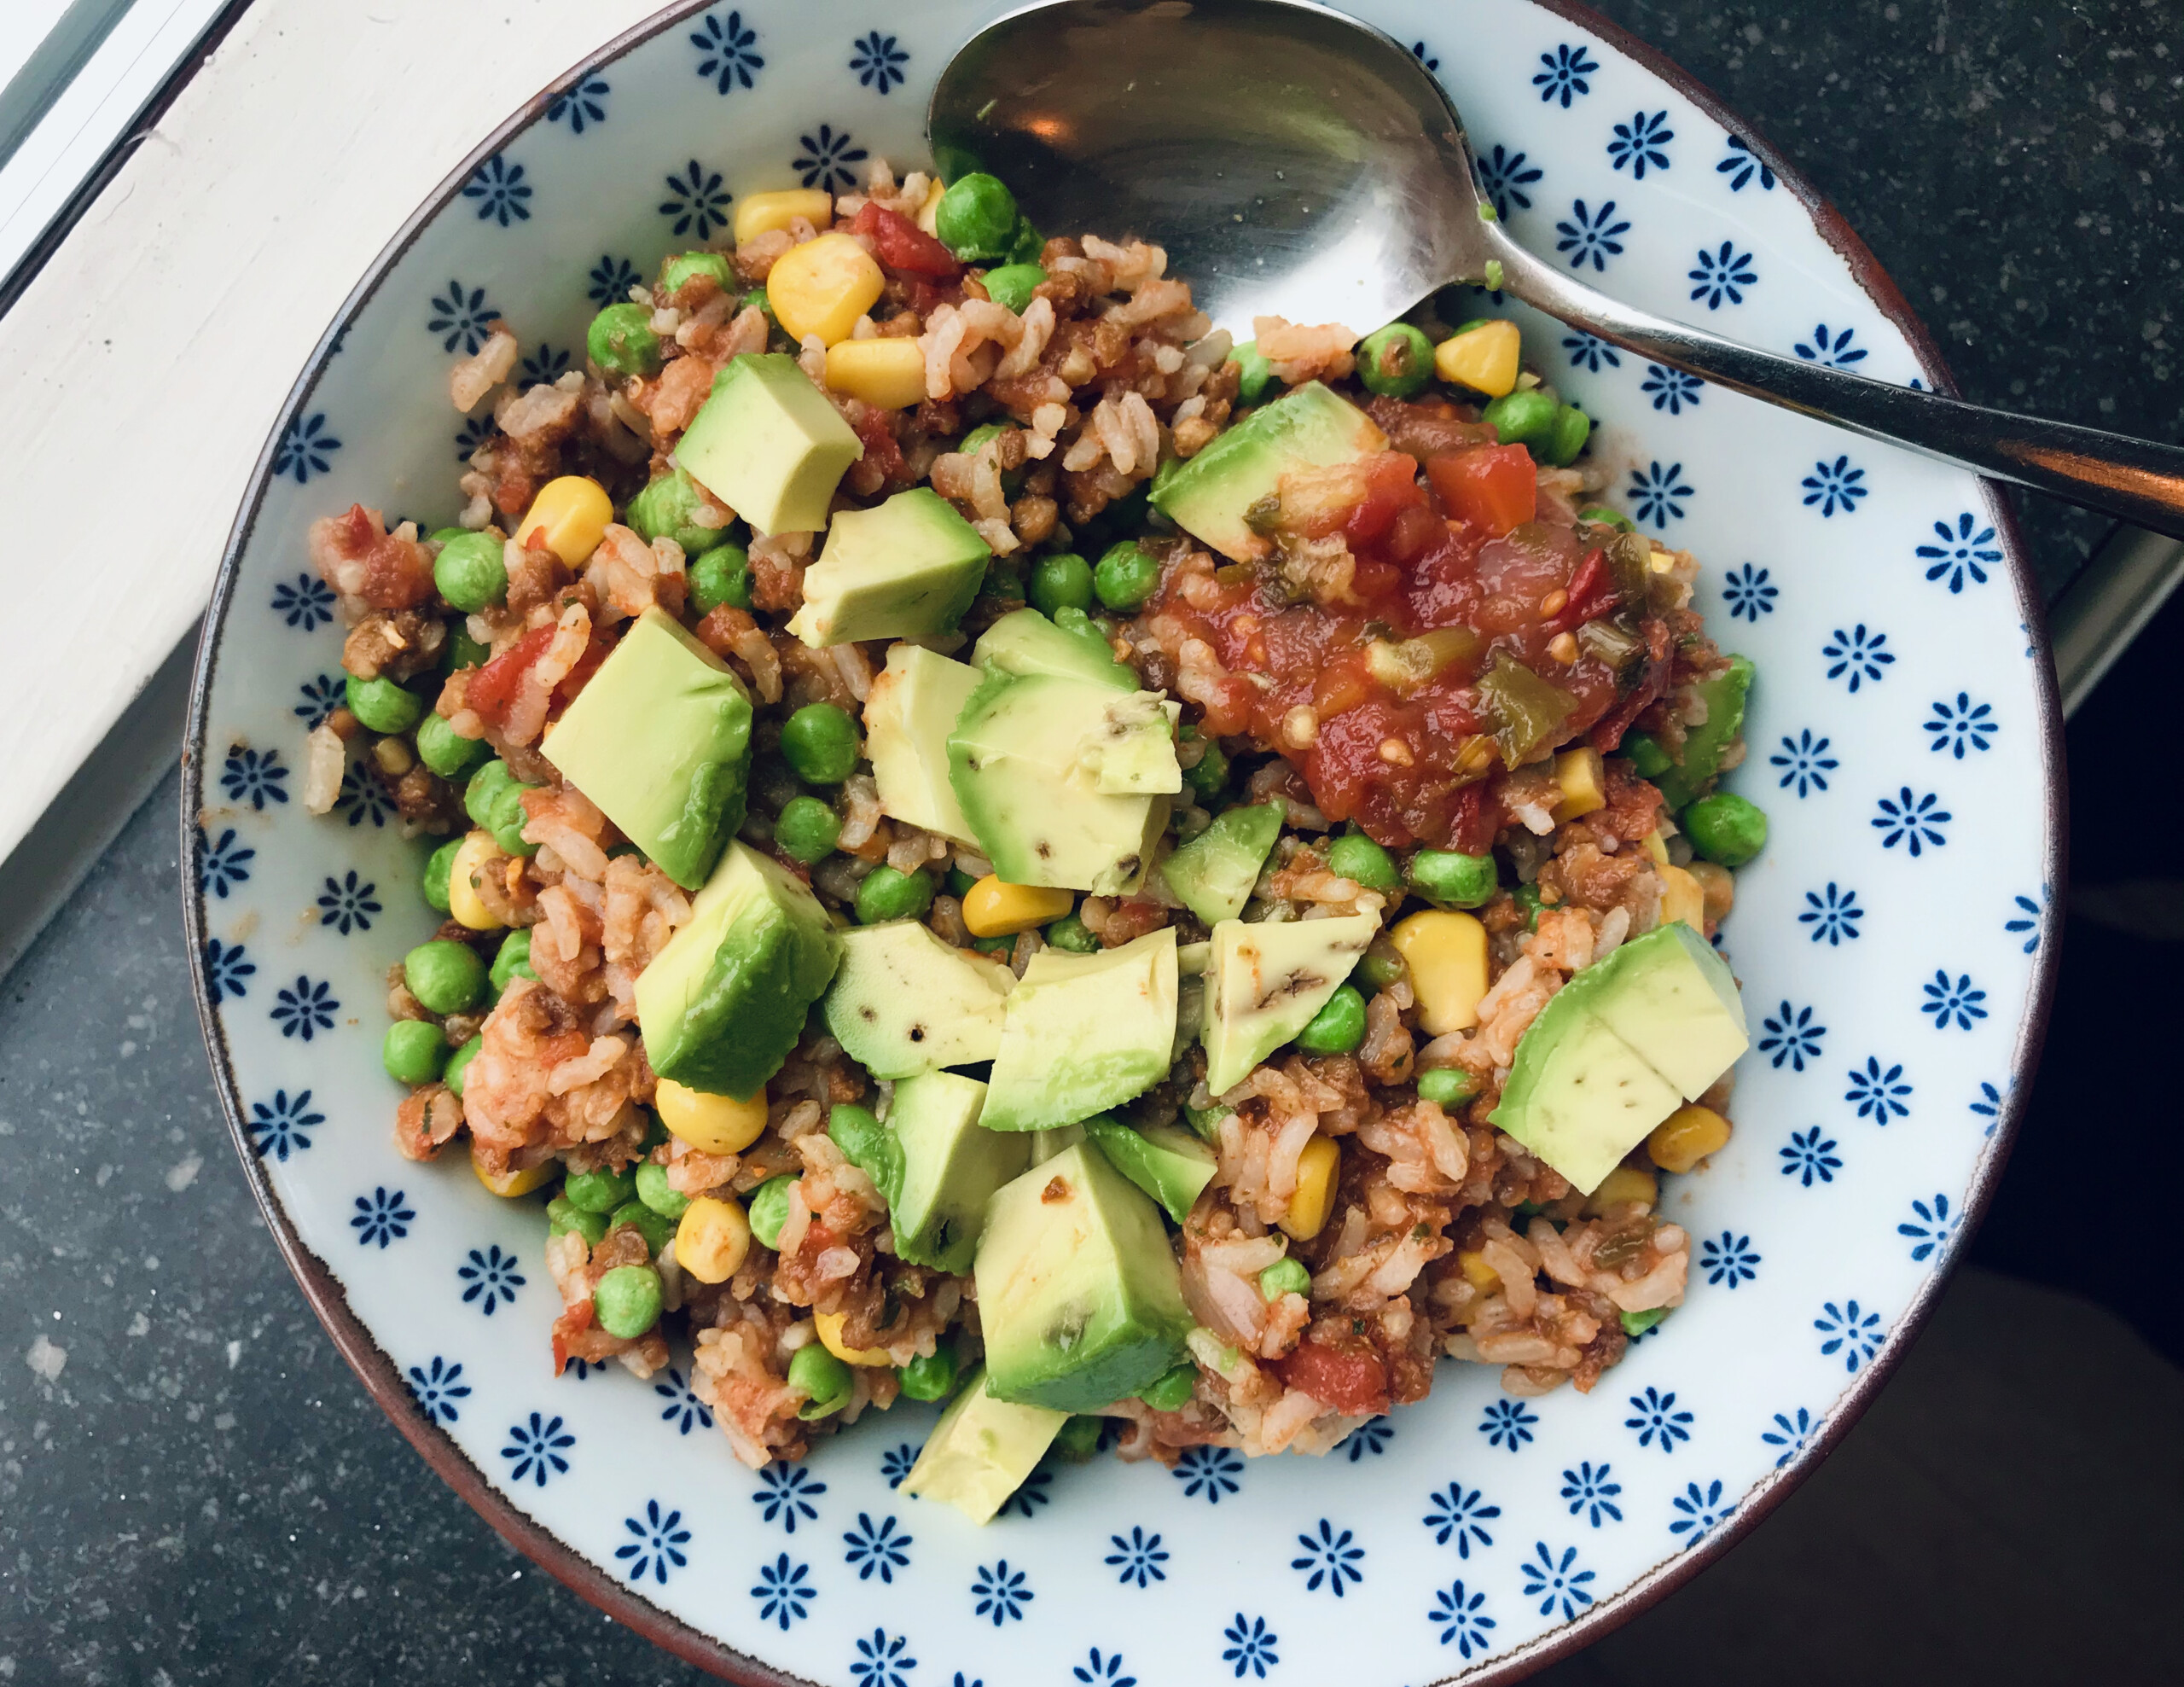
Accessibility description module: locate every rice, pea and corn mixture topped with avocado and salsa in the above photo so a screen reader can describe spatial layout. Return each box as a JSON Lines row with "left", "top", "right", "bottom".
{"left": 305, "top": 166, "right": 1764, "bottom": 1519}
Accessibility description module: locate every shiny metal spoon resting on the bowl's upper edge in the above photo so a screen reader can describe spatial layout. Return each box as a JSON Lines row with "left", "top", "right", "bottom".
{"left": 926, "top": 0, "right": 2184, "bottom": 538}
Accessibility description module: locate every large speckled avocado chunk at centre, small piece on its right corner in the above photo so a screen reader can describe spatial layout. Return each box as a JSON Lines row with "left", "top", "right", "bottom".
{"left": 948, "top": 669, "right": 1182, "bottom": 896}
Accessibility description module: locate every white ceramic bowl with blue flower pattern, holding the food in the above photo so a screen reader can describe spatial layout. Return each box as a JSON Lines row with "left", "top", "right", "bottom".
{"left": 183, "top": 0, "right": 2059, "bottom": 1687}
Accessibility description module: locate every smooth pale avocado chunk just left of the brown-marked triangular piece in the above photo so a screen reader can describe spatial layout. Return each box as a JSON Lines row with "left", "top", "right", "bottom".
{"left": 980, "top": 927, "right": 1179, "bottom": 1130}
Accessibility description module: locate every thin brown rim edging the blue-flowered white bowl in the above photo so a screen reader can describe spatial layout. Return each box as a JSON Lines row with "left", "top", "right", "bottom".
{"left": 181, "top": 0, "right": 2066, "bottom": 1687}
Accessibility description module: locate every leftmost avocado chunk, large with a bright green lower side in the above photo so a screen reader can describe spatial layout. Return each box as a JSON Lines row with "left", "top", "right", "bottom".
{"left": 539, "top": 609, "right": 752, "bottom": 889}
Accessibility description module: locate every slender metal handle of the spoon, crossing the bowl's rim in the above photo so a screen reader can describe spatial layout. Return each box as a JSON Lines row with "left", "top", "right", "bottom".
{"left": 1487, "top": 227, "right": 2184, "bottom": 538}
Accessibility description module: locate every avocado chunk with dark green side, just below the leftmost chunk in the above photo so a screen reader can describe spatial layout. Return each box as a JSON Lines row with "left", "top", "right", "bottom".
{"left": 638, "top": 841, "right": 839, "bottom": 1102}
